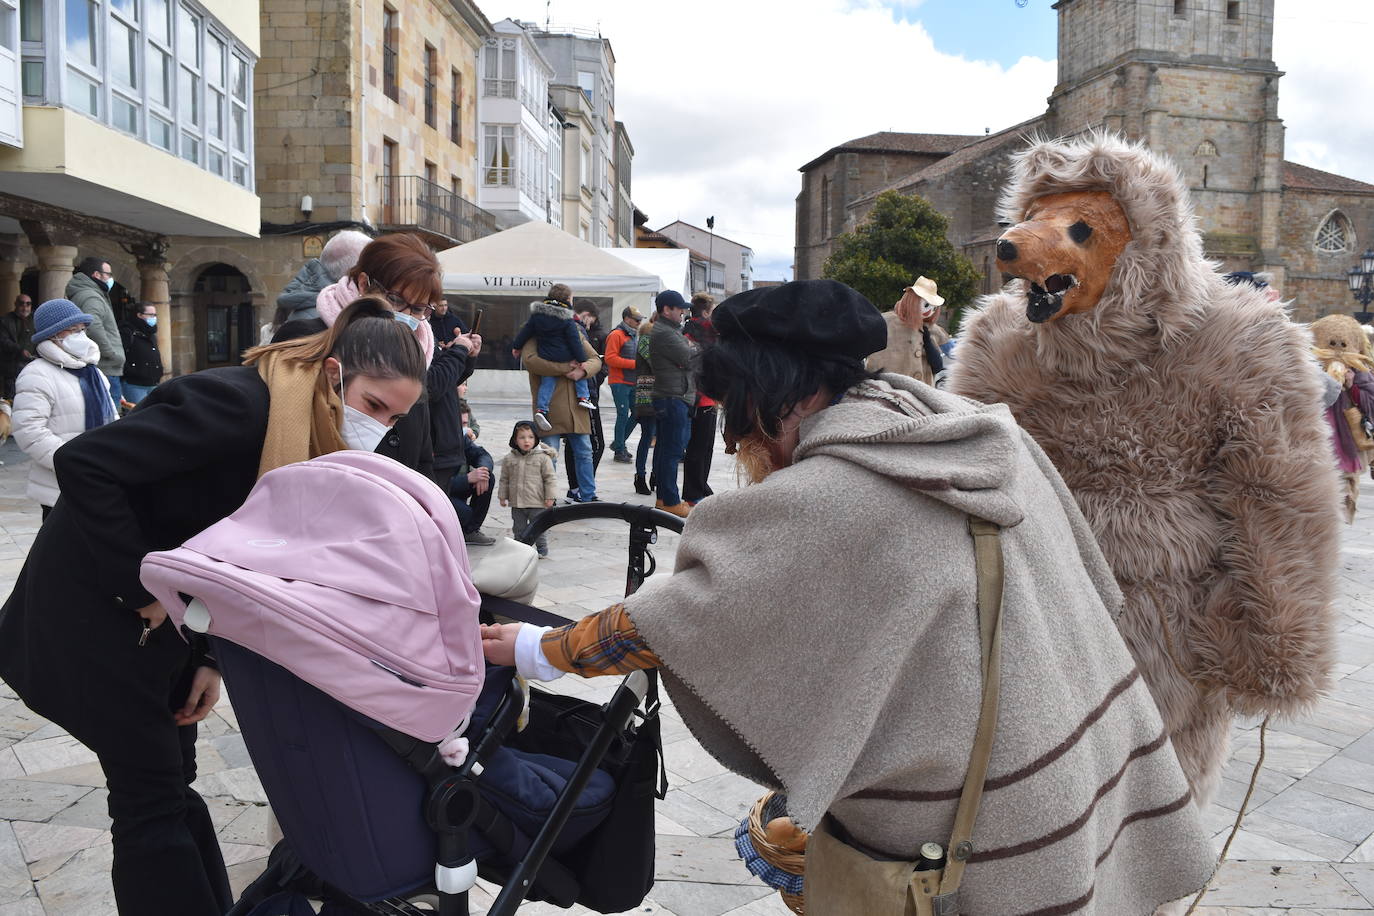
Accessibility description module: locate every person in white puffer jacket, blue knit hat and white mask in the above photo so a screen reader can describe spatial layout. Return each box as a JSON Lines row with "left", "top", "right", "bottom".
{"left": 11, "top": 299, "right": 118, "bottom": 520}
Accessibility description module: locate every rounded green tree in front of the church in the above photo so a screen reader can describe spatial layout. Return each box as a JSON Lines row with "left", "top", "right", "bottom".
{"left": 822, "top": 191, "right": 981, "bottom": 334}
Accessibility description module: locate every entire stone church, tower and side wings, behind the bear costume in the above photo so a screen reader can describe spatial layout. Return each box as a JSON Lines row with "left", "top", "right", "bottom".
{"left": 796, "top": 0, "right": 1374, "bottom": 321}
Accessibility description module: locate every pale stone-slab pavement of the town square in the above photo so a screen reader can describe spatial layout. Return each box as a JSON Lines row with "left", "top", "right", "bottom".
{"left": 0, "top": 401, "right": 1374, "bottom": 916}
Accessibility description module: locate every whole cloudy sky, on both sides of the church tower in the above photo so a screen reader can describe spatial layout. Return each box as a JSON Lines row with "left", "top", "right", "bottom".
{"left": 500, "top": 0, "right": 1374, "bottom": 279}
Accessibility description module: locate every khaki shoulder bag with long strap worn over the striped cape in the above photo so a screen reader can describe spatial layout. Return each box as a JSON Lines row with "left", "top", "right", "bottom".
{"left": 804, "top": 518, "right": 1003, "bottom": 916}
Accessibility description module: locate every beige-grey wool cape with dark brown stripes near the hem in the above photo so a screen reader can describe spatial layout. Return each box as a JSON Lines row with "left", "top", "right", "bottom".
{"left": 625, "top": 374, "right": 1215, "bottom": 916}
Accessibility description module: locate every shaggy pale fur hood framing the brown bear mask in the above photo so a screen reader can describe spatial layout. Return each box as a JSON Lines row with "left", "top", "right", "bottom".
{"left": 982, "top": 133, "right": 1242, "bottom": 378}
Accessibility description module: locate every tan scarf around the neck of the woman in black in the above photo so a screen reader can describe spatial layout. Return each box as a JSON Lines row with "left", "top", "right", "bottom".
{"left": 257, "top": 352, "right": 348, "bottom": 477}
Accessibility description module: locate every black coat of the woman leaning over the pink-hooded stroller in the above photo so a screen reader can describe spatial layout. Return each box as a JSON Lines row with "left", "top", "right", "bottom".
{"left": 0, "top": 367, "right": 268, "bottom": 733}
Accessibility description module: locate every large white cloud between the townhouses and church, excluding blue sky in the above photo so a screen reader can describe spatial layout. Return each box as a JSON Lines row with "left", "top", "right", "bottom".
{"left": 505, "top": 0, "right": 1054, "bottom": 279}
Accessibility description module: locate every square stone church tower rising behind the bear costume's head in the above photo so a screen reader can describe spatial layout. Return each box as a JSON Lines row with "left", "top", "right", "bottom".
{"left": 1047, "top": 0, "right": 1283, "bottom": 284}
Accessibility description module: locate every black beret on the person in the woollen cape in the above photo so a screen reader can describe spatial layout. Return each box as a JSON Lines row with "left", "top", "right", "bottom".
{"left": 710, "top": 280, "right": 888, "bottom": 360}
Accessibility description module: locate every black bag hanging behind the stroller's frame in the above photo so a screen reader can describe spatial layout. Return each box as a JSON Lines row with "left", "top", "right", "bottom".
{"left": 510, "top": 672, "right": 668, "bottom": 913}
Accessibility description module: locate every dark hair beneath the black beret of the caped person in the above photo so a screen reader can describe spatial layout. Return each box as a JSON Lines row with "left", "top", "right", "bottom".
{"left": 697, "top": 335, "right": 878, "bottom": 442}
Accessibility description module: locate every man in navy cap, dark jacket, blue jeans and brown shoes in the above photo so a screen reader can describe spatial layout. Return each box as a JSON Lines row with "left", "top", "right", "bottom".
{"left": 649, "top": 290, "right": 697, "bottom": 518}
